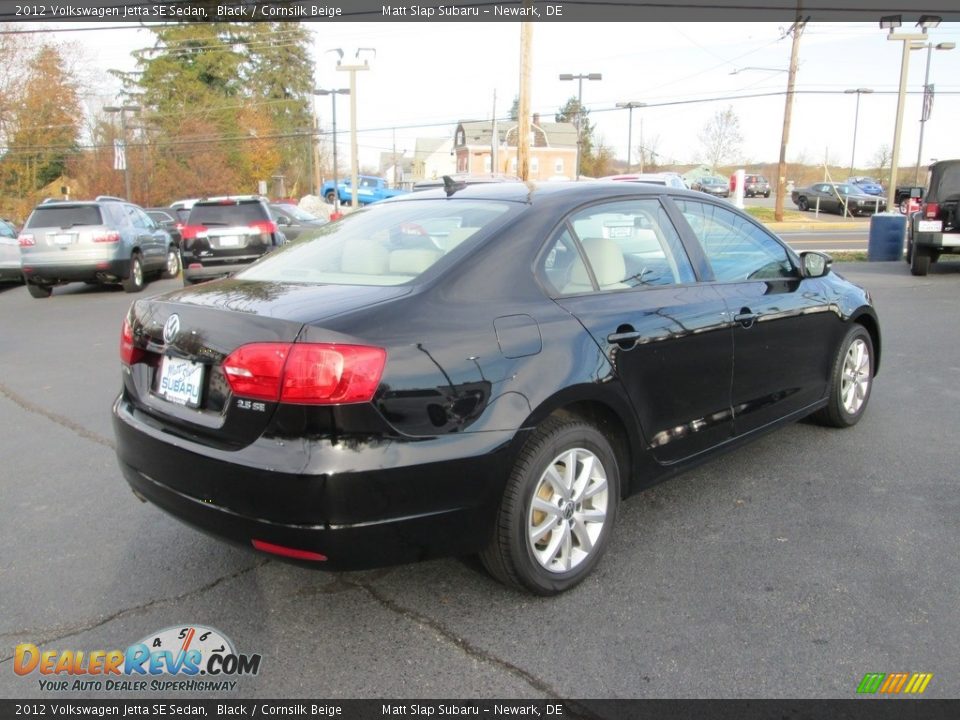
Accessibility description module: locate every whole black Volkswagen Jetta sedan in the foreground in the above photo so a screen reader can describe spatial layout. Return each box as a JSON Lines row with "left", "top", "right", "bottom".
{"left": 114, "top": 183, "right": 880, "bottom": 594}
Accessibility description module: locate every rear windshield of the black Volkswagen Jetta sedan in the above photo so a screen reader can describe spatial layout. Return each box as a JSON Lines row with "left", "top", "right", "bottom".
{"left": 236, "top": 199, "right": 524, "bottom": 285}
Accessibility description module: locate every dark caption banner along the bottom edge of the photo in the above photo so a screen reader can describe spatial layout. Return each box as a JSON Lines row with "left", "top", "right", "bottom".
{"left": 0, "top": 698, "right": 960, "bottom": 720}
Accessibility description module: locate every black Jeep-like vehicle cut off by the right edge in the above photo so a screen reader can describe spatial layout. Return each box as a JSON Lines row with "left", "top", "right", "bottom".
{"left": 907, "top": 160, "right": 960, "bottom": 275}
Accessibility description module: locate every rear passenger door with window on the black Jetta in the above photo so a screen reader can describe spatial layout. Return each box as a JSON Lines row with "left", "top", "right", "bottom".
{"left": 540, "top": 198, "right": 733, "bottom": 463}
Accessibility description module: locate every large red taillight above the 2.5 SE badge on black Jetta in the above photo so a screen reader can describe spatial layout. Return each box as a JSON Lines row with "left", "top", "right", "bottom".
{"left": 223, "top": 343, "right": 387, "bottom": 405}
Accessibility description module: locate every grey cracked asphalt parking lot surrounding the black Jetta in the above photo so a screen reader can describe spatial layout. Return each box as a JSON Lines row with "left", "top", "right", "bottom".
{"left": 0, "top": 262, "right": 960, "bottom": 698}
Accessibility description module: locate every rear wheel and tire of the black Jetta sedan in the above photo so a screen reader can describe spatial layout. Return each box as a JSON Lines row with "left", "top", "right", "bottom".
{"left": 480, "top": 417, "right": 620, "bottom": 595}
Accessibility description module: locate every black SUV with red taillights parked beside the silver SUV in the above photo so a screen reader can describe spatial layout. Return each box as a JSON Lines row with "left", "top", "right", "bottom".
{"left": 180, "top": 196, "right": 286, "bottom": 285}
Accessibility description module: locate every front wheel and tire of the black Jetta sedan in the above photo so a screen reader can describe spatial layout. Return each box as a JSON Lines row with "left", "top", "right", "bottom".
{"left": 814, "top": 324, "right": 874, "bottom": 428}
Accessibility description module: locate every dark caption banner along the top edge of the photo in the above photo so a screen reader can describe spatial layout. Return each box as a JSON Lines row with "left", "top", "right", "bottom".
{"left": 0, "top": 0, "right": 960, "bottom": 26}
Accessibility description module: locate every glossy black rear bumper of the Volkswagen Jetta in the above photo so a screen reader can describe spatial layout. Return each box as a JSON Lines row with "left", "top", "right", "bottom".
{"left": 113, "top": 395, "right": 516, "bottom": 570}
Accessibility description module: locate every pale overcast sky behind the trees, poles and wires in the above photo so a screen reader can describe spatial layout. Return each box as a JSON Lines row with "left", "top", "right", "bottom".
{"left": 16, "top": 22, "right": 960, "bottom": 177}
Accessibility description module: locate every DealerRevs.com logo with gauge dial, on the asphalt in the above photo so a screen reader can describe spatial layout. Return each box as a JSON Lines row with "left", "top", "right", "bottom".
{"left": 13, "top": 625, "right": 261, "bottom": 692}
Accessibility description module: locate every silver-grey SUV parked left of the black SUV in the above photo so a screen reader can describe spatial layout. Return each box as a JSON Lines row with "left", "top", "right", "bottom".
{"left": 19, "top": 200, "right": 180, "bottom": 298}
